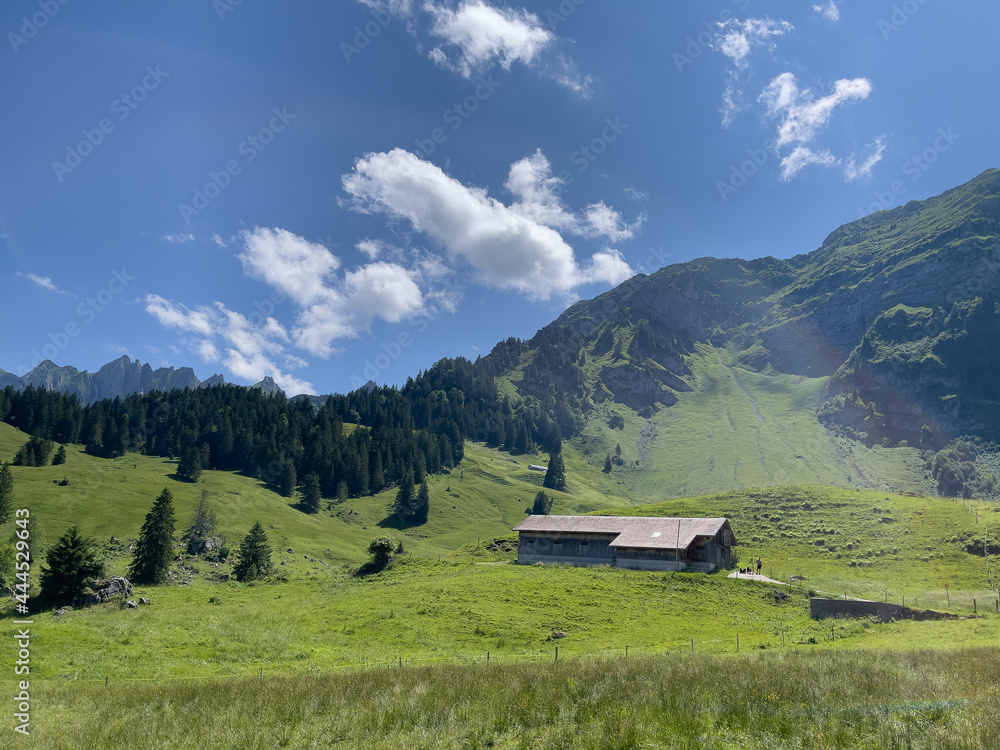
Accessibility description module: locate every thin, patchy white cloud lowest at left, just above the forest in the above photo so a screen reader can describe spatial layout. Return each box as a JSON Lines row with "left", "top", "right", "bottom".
{"left": 144, "top": 294, "right": 315, "bottom": 396}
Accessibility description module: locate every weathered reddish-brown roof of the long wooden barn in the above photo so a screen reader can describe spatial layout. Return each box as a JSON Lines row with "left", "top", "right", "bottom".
{"left": 514, "top": 516, "right": 736, "bottom": 549}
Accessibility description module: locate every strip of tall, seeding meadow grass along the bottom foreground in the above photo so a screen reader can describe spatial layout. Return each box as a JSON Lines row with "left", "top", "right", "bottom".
{"left": 31, "top": 648, "right": 1000, "bottom": 750}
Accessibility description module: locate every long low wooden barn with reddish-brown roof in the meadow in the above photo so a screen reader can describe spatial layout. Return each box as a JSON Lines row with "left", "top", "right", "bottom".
{"left": 514, "top": 516, "right": 736, "bottom": 572}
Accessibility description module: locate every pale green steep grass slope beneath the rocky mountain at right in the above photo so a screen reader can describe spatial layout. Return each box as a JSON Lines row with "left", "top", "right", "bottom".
{"left": 572, "top": 344, "right": 932, "bottom": 502}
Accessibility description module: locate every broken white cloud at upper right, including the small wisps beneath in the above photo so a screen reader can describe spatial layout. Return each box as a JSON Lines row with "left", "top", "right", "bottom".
{"left": 759, "top": 73, "right": 881, "bottom": 181}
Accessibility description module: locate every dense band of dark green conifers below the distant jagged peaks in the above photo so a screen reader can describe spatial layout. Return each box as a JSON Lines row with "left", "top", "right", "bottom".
{"left": 0, "top": 338, "right": 572, "bottom": 506}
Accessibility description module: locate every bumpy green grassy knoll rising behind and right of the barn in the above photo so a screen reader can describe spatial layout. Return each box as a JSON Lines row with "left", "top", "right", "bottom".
{"left": 596, "top": 486, "right": 1000, "bottom": 611}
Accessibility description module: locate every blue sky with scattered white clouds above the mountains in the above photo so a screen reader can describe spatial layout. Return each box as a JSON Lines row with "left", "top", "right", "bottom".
{"left": 0, "top": 0, "right": 1000, "bottom": 395}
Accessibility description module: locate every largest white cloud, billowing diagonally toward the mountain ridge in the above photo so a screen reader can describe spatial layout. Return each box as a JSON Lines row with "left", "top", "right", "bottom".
{"left": 342, "top": 148, "right": 631, "bottom": 299}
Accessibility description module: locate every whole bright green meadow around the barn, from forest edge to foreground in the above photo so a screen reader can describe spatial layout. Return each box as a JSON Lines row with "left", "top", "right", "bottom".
{"left": 0, "top": 420, "right": 1000, "bottom": 748}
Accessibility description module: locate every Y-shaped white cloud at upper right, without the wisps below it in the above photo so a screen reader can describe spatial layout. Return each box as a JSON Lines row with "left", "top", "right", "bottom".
{"left": 760, "top": 73, "right": 872, "bottom": 147}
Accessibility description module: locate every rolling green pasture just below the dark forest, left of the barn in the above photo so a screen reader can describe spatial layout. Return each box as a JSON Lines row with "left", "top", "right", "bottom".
{"left": 0, "top": 423, "right": 629, "bottom": 572}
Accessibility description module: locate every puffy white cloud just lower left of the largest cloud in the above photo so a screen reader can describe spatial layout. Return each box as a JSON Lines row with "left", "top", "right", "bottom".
{"left": 238, "top": 227, "right": 423, "bottom": 357}
